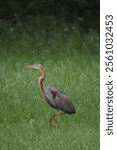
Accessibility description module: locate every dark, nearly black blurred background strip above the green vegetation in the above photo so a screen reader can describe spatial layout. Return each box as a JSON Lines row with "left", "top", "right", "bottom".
{"left": 0, "top": 0, "right": 100, "bottom": 27}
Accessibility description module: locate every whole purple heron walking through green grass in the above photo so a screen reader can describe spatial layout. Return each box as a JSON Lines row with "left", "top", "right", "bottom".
{"left": 24, "top": 64, "right": 76, "bottom": 128}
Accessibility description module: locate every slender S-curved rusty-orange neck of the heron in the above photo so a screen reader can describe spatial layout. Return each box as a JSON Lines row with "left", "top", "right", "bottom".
{"left": 38, "top": 68, "right": 46, "bottom": 97}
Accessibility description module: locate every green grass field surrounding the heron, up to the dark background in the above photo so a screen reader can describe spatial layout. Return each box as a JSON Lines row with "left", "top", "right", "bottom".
{"left": 0, "top": 17, "right": 99, "bottom": 150}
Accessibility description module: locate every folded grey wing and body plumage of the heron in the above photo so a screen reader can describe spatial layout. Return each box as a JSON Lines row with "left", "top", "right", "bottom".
{"left": 46, "top": 88, "right": 75, "bottom": 114}
